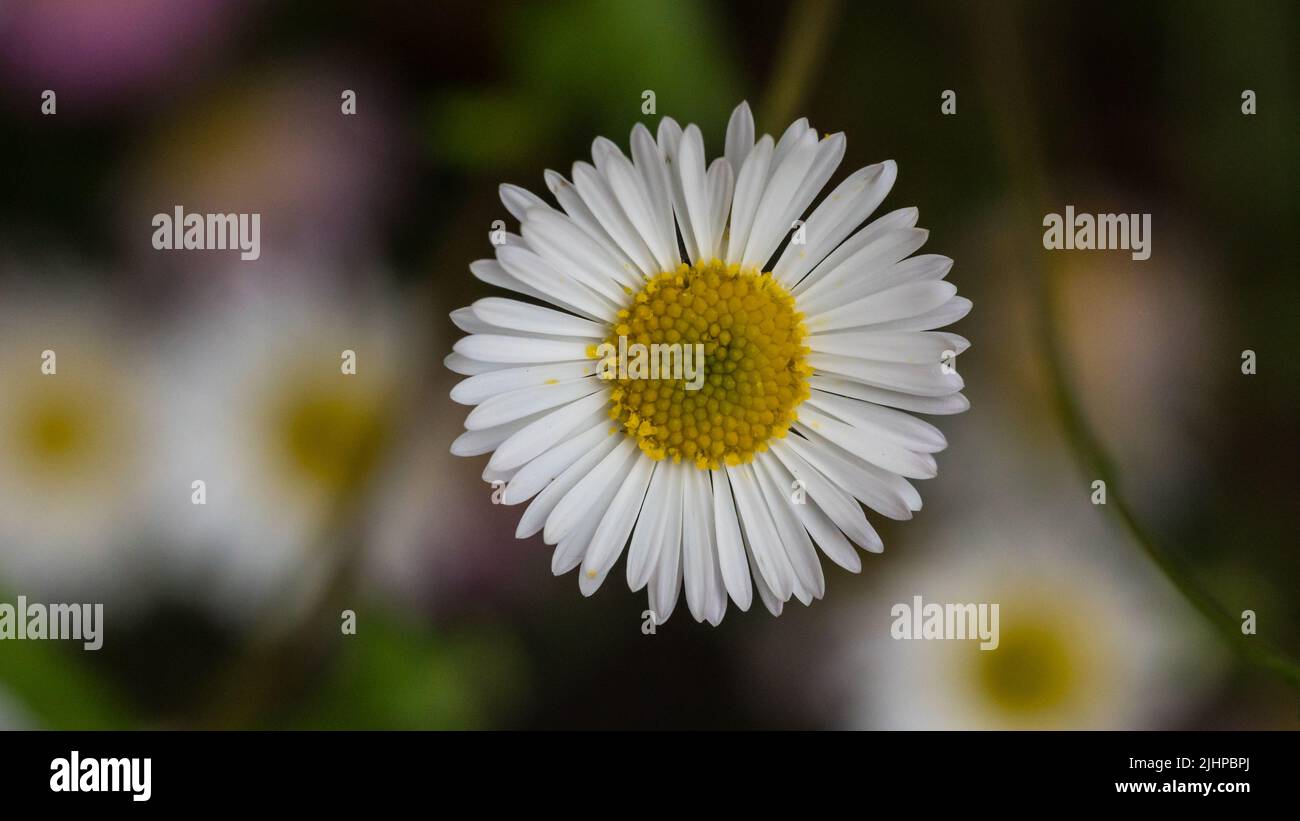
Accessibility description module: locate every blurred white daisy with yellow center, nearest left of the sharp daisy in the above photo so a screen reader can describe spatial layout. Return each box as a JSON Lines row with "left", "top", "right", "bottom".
{"left": 157, "top": 290, "right": 419, "bottom": 622}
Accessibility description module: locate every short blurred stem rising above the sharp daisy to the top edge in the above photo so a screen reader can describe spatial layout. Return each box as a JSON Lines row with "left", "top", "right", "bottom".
{"left": 759, "top": 0, "right": 840, "bottom": 131}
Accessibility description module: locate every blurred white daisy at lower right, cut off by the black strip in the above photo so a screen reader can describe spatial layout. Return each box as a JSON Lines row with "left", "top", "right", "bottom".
{"left": 813, "top": 504, "right": 1223, "bottom": 730}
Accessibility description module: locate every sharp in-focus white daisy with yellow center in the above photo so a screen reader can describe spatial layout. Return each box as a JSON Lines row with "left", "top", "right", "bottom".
{"left": 447, "top": 104, "right": 971, "bottom": 625}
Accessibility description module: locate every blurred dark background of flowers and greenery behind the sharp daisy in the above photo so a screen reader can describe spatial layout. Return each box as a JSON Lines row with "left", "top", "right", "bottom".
{"left": 0, "top": 0, "right": 1300, "bottom": 729}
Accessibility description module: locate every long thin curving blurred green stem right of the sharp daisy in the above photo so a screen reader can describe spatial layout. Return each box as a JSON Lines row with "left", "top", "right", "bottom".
{"left": 974, "top": 4, "right": 1300, "bottom": 688}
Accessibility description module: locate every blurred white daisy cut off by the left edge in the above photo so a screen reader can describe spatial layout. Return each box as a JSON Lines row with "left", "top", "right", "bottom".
{"left": 0, "top": 294, "right": 153, "bottom": 604}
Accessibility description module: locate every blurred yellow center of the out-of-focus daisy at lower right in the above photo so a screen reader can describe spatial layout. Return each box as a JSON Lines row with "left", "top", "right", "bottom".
{"left": 976, "top": 622, "right": 1079, "bottom": 716}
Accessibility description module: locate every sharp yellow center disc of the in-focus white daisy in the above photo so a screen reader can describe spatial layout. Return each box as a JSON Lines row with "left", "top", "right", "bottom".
{"left": 589, "top": 260, "right": 810, "bottom": 469}
